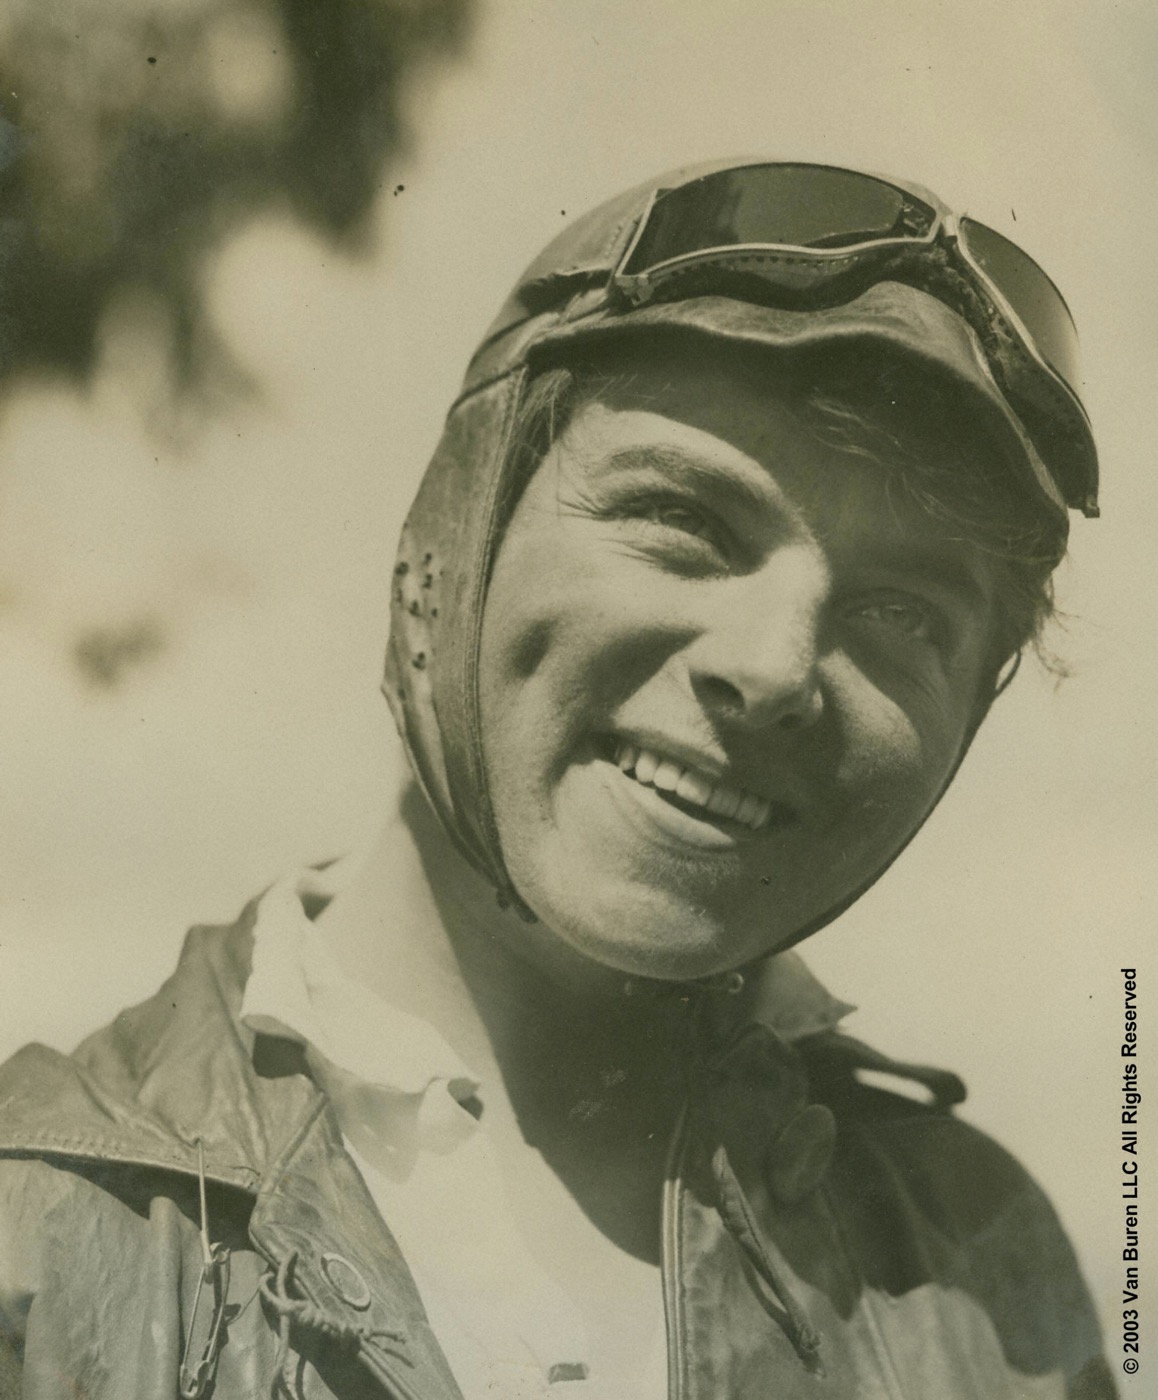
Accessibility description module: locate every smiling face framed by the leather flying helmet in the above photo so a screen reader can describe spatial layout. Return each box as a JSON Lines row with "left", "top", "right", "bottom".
{"left": 480, "top": 353, "right": 994, "bottom": 979}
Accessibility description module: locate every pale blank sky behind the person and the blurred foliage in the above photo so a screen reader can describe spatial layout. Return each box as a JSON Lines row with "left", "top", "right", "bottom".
{"left": 0, "top": 0, "right": 1158, "bottom": 1355}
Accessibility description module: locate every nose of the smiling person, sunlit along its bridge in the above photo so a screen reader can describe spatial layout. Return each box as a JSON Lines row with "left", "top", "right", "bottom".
{"left": 686, "top": 546, "right": 830, "bottom": 729}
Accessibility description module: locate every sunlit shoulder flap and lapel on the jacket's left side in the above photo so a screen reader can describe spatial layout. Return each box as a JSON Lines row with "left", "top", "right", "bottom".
{"left": 0, "top": 902, "right": 461, "bottom": 1400}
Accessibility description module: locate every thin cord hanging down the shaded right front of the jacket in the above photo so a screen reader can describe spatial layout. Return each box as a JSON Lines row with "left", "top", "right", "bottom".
{"left": 683, "top": 988, "right": 822, "bottom": 1372}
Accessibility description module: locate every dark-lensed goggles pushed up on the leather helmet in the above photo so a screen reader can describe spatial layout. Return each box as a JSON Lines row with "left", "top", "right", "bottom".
{"left": 612, "top": 164, "right": 1098, "bottom": 515}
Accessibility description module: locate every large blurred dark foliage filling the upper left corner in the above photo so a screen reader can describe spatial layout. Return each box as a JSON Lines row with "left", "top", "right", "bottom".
{"left": 0, "top": 0, "right": 473, "bottom": 388}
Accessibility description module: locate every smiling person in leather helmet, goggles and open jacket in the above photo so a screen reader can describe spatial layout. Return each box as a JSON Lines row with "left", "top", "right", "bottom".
{"left": 0, "top": 164, "right": 1113, "bottom": 1400}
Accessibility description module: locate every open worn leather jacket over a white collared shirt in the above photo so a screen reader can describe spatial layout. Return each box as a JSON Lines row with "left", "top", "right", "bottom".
{"left": 0, "top": 906, "right": 1115, "bottom": 1400}
